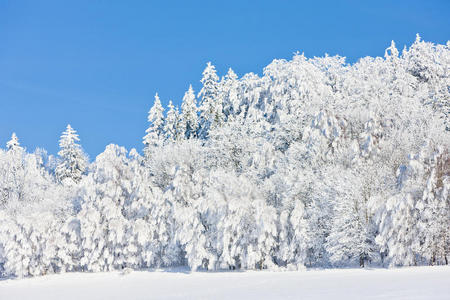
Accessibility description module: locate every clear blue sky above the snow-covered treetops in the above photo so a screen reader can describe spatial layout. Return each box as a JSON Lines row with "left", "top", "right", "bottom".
{"left": 0, "top": 0, "right": 450, "bottom": 158}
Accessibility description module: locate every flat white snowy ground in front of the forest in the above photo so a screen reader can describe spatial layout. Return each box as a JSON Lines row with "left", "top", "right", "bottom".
{"left": 0, "top": 267, "right": 450, "bottom": 300}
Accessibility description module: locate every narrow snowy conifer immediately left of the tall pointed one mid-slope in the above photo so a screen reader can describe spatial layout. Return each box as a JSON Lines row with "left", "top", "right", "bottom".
{"left": 179, "top": 85, "right": 198, "bottom": 139}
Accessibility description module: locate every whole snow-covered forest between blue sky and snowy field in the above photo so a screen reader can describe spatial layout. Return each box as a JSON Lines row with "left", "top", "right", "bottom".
{"left": 0, "top": 36, "right": 450, "bottom": 277}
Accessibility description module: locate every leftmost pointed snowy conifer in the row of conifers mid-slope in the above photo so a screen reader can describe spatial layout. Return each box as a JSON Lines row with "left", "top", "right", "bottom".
{"left": 143, "top": 93, "right": 164, "bottom": 158}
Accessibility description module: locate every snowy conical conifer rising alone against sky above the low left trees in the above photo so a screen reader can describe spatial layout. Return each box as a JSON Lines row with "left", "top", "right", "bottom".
{"left": 55, "top": 124, "right": 88, "bottom": 184}
